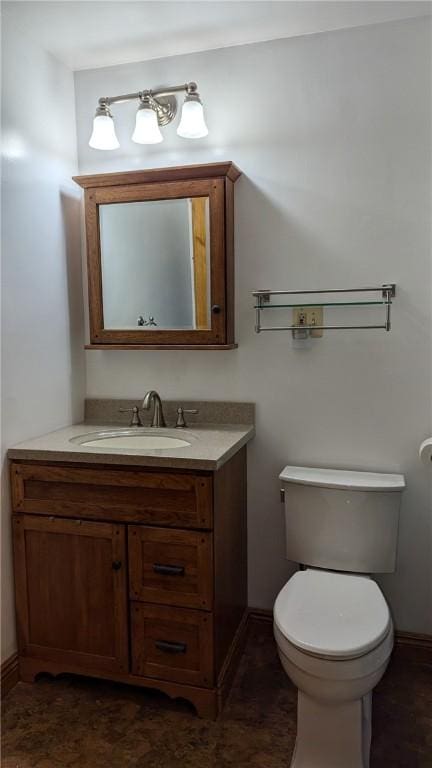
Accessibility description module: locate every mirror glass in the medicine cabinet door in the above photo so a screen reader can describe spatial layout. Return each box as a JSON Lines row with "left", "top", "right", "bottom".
{"left": 99, "top": 197, "right": 211, "bottom": 331}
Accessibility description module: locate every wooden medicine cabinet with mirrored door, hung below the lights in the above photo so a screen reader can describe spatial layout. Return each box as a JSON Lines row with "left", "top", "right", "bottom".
{"left": 74, "top": 162, "right": 240, "bottom": 349}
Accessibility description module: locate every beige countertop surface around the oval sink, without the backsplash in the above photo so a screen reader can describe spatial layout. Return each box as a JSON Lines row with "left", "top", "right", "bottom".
{"left": 8, "top": 422, "right": 255, "bottom": 470}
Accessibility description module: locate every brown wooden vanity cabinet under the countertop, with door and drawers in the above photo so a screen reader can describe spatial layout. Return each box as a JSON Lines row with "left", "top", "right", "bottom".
{"left": 11, "top": 448, "right": 247, "bottom": 717}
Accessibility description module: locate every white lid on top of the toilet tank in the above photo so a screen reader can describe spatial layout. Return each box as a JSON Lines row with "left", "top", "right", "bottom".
{"left": 279, "top": 465, "right": 405, "bottom": 491}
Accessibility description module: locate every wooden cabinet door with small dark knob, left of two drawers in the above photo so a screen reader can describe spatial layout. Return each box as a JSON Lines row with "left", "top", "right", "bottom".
{"left": 13, "top": 515, "right": 128, "bottom": 672}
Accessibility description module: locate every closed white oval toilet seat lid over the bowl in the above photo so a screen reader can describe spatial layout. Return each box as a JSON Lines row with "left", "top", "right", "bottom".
{"left": 274, "top": 569, "right": 391, "bottom": 659}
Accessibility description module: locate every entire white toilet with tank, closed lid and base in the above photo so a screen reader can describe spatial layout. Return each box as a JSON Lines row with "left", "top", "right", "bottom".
{"left": 274, "top": 466, "right": 405, "bottom": 768}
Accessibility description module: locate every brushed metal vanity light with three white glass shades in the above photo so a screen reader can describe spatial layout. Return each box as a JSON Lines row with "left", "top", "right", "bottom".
{"left": 89, "top": 82, "right": 208, "bottom": 149}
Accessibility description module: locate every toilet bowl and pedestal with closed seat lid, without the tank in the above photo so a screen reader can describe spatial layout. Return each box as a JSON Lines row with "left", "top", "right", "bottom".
{"left": 274, "top": 569, "right": 393, "bottom": 768}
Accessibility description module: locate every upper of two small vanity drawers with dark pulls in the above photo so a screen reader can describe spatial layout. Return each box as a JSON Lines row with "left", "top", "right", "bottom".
{"left": 128, "top": 525, "right": 213, "bottom": 610}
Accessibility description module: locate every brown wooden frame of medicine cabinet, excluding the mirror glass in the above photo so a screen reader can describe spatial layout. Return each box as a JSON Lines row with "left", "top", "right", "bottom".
{"left": 73, "top": 162, "right": 240, "bottom": 349}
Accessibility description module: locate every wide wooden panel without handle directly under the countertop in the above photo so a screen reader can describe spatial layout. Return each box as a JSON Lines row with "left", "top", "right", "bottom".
{"left": 11, "top": 463, "right": 213, "bottom": 529}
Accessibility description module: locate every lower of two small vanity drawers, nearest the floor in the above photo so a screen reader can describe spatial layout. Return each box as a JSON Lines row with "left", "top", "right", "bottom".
{"left": 131, "top": 602, "right": 213, "bottom": 688}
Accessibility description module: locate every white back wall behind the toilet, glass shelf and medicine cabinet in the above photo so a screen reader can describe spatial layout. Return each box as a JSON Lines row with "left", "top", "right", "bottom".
{"left": 75, "top": 19, "right": 432, "bottom": 632}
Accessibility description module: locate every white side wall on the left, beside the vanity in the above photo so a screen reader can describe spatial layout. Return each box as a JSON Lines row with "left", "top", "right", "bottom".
{"left": 1, "top": 12, "right": 84, "bottom": 659}
